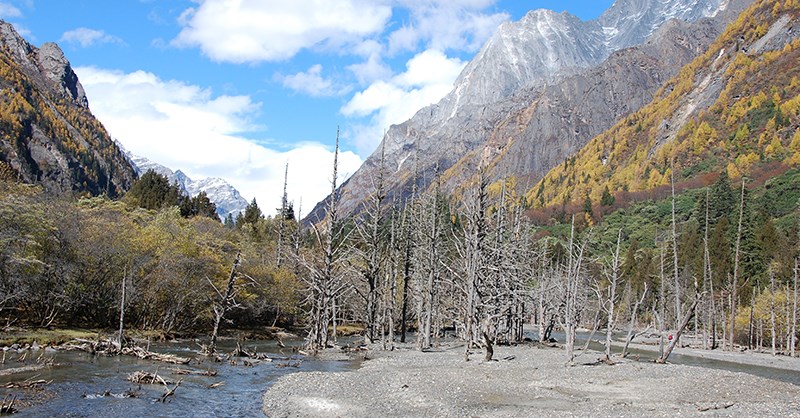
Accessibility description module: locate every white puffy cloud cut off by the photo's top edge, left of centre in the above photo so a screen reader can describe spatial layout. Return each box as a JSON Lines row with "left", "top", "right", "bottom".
{"left": 172, "top": 0, "right": 392, "bottom": 63}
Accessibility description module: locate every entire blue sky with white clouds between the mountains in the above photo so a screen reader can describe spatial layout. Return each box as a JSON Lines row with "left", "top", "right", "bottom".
{"left": 0, "top": 0, "right": 612, "bottom": 213}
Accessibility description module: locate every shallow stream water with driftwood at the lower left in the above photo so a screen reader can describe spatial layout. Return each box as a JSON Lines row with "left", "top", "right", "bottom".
{"left": 0, "top": 341, "right": 358, "bottom": 417}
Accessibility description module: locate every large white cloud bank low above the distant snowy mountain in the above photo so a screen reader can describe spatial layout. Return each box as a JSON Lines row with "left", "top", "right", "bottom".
{"left": 75, "top": 67, "right": 361, "bottom": 219}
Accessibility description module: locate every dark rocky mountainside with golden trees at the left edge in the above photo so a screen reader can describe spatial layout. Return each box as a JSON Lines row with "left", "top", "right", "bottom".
{"left": 0, "top": 21, "right": 136, "bottom": 197}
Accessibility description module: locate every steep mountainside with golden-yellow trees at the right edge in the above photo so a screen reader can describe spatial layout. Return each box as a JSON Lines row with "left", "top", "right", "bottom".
{"left": 527, "top": 0, "right": 800, "bottom": 207}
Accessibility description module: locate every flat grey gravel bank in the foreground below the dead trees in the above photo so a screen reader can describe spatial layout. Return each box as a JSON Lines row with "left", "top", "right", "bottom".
{"left": 263, "top": 345, "right": 800, "bottom": 417}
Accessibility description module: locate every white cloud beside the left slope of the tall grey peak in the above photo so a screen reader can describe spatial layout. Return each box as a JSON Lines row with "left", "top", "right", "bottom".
{"left": 341, "top": 50, "right": 466, "bottom": 155}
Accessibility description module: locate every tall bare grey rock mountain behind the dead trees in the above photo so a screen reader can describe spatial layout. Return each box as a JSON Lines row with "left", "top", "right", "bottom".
{"left": 307, "top": 0, "right": 751, "bottom": 222}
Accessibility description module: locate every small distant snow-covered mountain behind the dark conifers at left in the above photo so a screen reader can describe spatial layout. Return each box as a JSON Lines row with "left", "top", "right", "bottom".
{"left": 127, "top": 152, "right": 248, "bottom": 219}
